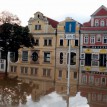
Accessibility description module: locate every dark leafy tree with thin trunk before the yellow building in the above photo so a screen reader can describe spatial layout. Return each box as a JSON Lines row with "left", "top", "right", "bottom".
{"left": 0, "top": 23, "right": 34, "bottom": 77}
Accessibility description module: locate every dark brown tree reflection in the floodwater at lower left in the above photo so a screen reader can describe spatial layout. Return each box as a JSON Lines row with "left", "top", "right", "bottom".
{"left": 0, "top": 79, "right": 32, "bottom": 107}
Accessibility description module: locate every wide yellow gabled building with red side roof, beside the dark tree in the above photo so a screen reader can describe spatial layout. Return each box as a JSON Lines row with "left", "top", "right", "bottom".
{"left": 9, "top": 12, "right": 58, "bottom": 94}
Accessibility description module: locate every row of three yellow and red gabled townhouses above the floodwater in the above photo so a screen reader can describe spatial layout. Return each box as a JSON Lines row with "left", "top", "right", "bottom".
{"left": 0, "top": 5, "right": 107, "bottom": 97}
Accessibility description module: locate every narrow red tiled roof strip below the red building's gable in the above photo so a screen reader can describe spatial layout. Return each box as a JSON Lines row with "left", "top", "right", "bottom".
{"left": 81, "top": 27, "right": 107, "bottom": 31}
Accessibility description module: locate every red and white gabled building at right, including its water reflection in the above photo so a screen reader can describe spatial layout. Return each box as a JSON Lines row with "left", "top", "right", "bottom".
{"left": 79, "top": 5, "right": 107, "bottom": 107}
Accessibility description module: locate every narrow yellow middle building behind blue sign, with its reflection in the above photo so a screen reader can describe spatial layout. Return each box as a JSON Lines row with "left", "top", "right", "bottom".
{"left": 55, "top": 17, "right": 80, "bottom": 95}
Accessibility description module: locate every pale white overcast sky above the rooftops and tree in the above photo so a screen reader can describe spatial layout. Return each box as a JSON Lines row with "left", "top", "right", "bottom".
{"left": 0, "top": 0, "right": 107, "bottom": 26}
